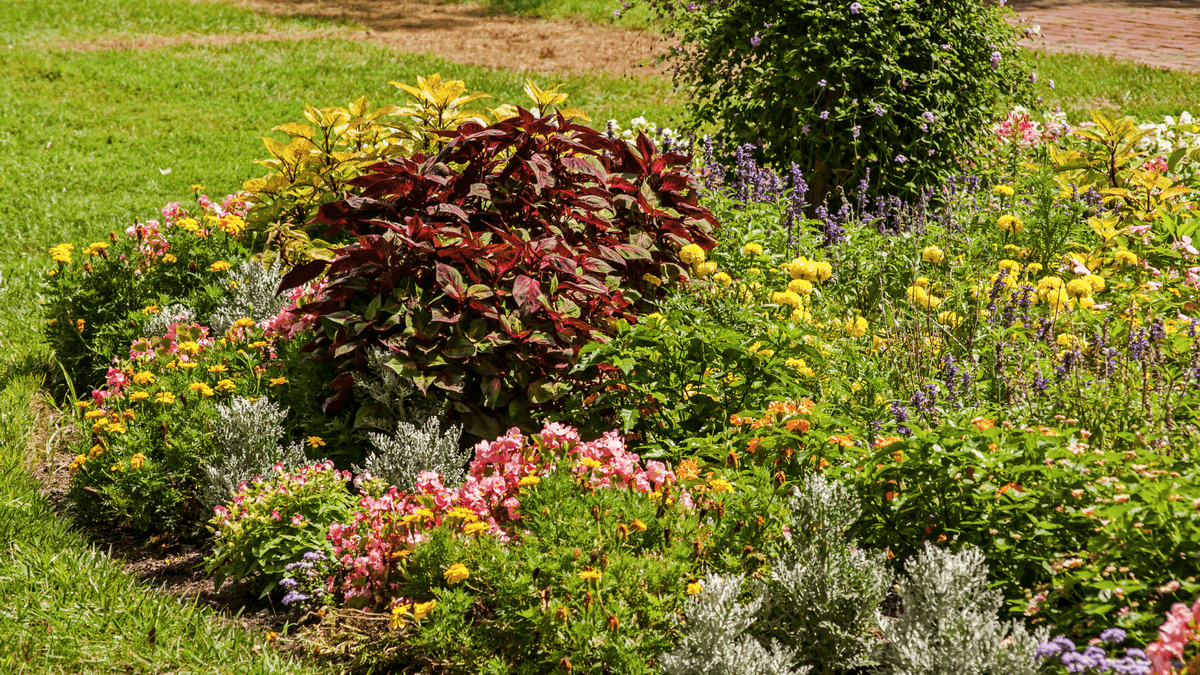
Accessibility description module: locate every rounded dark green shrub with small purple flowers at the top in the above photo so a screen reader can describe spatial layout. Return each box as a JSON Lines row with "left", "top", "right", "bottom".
{"left": 650, "top": 0, "right": 1030, "bottom": 196}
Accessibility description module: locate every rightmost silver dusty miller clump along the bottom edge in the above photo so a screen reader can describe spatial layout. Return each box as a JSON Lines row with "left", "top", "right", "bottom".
{"left": 878, "top": 542, "right": 1049, "bottom": 675}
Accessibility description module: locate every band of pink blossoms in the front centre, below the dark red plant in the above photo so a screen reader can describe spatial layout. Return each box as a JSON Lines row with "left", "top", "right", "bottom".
{"left": 329, "top": 423, "right": 691, "bottom": 607}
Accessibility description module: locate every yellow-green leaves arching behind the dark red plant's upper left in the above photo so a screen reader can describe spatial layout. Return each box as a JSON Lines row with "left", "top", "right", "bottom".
{"left": 242, "top": 73, "right": 588, "bottom": 265}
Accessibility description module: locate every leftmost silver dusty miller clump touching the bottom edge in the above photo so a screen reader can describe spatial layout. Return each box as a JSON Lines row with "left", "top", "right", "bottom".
{"left": 659, "top": 574, "right": 809, "bottom": 675}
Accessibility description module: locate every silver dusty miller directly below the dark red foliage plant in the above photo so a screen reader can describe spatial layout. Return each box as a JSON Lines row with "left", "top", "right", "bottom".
{"left": 354, "top": 350, "right": 470, "bottom": 490}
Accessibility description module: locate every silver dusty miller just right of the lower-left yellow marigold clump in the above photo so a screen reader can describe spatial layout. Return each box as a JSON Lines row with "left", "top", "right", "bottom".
{"left": 200, "top": 396, "right": 306, "bottom": 508}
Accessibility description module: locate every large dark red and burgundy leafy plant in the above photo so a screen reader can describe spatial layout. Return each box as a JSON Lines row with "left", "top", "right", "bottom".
{"left": 281, "top": 109, "right": 716, "bottom": 437}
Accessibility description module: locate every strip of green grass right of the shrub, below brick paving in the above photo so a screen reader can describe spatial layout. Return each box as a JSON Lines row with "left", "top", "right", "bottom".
{"left": 1033, "top": 53, "right": 1200, "bottom": 121}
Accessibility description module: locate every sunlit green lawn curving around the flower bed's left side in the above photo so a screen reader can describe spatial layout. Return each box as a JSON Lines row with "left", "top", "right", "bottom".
{"left": 0, "top": 0, "right": 676, "bottom": 673}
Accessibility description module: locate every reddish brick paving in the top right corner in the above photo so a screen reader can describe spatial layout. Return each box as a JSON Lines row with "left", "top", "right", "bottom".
{"left": 1009, "top": 0, "right": 1200, "bottom": 72}
